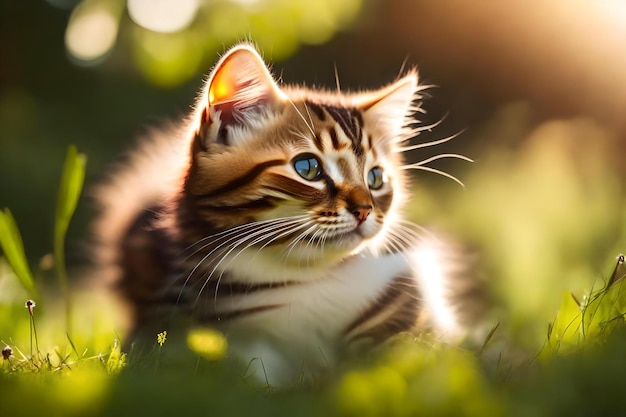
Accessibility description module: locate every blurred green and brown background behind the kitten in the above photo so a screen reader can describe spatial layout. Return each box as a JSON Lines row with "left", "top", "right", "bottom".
{"left": 0, "top": 0, "right": 626, "bottom": 356}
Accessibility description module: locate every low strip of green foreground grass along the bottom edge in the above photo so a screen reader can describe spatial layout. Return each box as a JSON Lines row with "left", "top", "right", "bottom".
{"left": 0, "top": 272, "right": 626, "bottom": 416}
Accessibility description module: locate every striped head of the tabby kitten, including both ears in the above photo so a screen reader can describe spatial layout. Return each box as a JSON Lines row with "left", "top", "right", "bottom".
{"left": 185, "top": 45, "right": 418, "bottom": 266}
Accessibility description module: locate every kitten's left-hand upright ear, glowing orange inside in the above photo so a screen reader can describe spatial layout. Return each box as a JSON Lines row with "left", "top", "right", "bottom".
{"left": 200, "top": 45, "right": 282, "bottom": 148}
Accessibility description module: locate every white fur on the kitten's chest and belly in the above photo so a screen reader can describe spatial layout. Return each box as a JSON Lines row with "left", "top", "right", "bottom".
{"left": 212, "top": 244, "right": 450, "bottom": 385}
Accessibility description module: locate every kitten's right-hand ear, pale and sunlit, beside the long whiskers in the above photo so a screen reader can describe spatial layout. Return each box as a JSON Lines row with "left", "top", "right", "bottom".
{"left": 359, "top": 71, "right": 420, "bottom": 135}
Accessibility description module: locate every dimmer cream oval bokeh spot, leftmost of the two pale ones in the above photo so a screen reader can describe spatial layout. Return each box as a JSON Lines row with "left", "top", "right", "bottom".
{"left": 65, "top": 2, "right": 119, "bottom": 62}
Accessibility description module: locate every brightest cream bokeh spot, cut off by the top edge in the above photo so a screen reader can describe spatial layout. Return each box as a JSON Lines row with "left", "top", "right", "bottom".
{"left": 128, "top": 0, "right": 200, "bottom": 33}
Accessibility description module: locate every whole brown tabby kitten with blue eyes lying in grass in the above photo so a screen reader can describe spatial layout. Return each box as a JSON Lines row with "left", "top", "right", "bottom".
{"left": 98, "top": 45, "right": 472, "bottom": 385}
